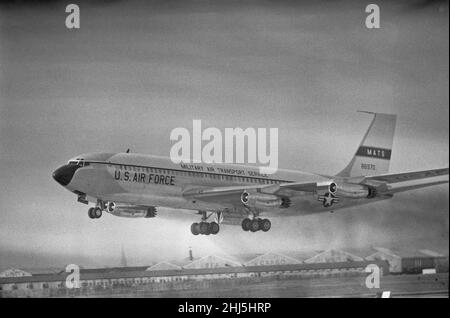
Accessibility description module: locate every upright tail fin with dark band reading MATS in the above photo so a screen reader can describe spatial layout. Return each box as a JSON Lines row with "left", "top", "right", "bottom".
{"left": 336, "top": 111, "right": 397, "bottom": 177}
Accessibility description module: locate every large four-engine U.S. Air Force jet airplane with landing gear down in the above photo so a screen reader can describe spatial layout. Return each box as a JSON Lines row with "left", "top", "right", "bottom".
{"left": 53, "top": 112, "right": 449, "bottom": 235}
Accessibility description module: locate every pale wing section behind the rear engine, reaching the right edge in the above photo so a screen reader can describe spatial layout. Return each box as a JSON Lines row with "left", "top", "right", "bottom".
{"left": 356, "top": 168, "right": 449, "bottom": 194}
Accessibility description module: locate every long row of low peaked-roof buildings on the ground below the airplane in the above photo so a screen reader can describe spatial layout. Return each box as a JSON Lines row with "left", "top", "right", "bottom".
{"left": 0, "top": 248, "right": 448, "bottom": 297}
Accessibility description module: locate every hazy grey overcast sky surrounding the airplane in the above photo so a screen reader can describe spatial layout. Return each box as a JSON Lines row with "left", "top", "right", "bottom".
{"left": 0, "top": 1, "right": 449, "bottom": 269}
